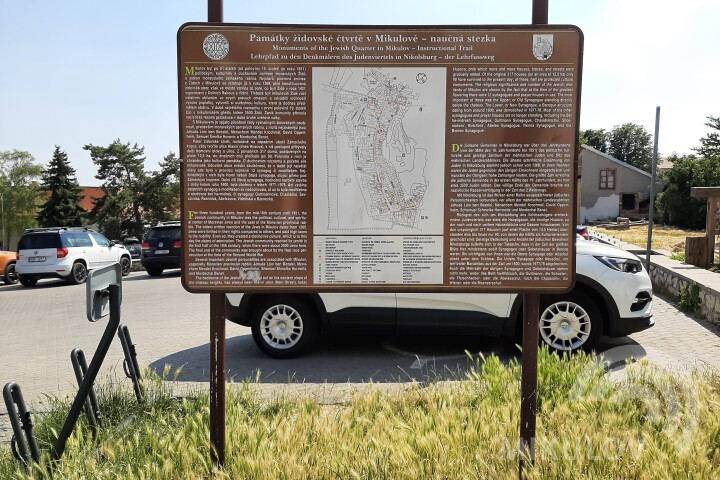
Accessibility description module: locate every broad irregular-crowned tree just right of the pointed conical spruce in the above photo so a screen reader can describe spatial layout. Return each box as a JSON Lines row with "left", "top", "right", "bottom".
{"left": 83, "top": 139, "right": 146, "bottom": 239}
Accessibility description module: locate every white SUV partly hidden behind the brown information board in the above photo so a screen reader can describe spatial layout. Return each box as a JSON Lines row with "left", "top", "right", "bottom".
{"left": 225, "top": 239, "right": 654, "bottom": 358}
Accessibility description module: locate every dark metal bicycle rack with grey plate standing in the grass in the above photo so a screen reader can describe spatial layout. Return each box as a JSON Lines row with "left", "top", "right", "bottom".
{"left": 3, "top": 264, "right": 144, "bottom": 464}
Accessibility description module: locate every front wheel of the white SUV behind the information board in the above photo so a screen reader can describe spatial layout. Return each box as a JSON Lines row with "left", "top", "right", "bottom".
{"left": 540, "top": 292, "right": 603, "bottom": 352}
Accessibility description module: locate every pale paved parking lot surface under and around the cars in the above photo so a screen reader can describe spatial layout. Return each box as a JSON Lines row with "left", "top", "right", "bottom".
{"left": 0, "top": 271, "right": 720, "bottom": 441}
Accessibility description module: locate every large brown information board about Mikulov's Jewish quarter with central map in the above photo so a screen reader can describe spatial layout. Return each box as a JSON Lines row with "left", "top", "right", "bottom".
{"left": 178, "top": 23, "right": 582, "bottom": 293}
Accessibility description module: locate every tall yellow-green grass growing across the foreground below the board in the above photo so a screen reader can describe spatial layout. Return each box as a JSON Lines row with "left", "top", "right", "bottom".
{"left": 0, "top": 350, "right": 720, "bottom": 480}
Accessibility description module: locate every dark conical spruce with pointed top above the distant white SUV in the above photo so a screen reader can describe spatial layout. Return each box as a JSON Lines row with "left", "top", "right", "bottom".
{"left": 37, "top": 145, "right": 85, "bottom": 227}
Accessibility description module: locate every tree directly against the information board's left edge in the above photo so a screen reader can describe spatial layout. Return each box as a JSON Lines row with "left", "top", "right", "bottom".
{"left": 141, "top": 152, "right": 180, "bottom": 225}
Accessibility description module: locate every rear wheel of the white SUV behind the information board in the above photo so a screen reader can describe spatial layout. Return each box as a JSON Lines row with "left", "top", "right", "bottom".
{"left": 250, "top": 297, "right": 320, "bottom": 358}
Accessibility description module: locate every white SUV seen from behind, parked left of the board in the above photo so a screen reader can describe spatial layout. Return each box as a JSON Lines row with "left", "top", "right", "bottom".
{"left": 15, "top": 227, "right": 132, "bottom": 287}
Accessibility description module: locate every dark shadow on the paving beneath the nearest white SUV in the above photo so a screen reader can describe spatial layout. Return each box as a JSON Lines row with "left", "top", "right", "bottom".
{"left": 149, "top": 334, "right": 645, "bottom": 384}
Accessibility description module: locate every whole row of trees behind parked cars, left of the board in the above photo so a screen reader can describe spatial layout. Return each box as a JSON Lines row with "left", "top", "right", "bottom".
{"left": 0, "top": 139, "right": 180, "bottom": 245}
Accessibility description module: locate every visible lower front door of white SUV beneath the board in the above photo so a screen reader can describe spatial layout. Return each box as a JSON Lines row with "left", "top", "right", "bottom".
{"left": 397, "top": 293, "right": 513, "bottom": 335}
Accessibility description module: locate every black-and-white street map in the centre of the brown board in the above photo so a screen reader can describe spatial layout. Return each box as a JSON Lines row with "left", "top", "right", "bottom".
{"left": 312, "top": 67, "right": 447, "bottom": 234}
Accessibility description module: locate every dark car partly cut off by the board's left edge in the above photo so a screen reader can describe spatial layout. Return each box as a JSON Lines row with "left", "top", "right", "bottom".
{"left": 140, "top": 221, "right": 182, "bottom": 277}
